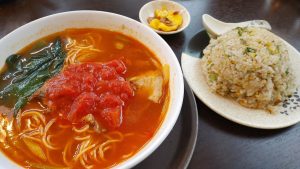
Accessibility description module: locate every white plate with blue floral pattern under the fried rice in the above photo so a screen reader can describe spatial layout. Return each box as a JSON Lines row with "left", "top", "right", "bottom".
{"left": 181, "top": 32, "right": 300, "bottom": 129}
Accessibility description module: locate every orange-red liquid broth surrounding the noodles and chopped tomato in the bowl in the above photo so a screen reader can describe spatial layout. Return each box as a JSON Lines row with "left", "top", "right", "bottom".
{"left": 0, "top": 29, "right": 169, "bottom": 168}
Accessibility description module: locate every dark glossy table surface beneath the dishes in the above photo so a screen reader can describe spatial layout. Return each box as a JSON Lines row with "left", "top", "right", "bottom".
{"left": 0, "top": 0, "right": 300, "bottom": 169}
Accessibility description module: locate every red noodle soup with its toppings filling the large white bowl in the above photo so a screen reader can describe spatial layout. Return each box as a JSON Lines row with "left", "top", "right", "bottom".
{"left": 0, "top": 29, "right": 169, "bottom": 168}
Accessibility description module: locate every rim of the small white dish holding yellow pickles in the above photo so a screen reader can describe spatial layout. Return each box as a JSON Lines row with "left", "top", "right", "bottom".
{"left": 139, "top": 0, "right": 191, "bottom": 35}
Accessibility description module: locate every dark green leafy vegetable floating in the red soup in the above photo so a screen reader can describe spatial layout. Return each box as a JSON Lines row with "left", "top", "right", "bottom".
{"left": 0, "top": 39, "right": 66, "bottom": 116}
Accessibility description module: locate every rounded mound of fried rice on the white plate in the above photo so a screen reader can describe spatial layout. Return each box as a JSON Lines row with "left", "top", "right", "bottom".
{"left": 201, "top": 27, "right": 294, "bottom": 110}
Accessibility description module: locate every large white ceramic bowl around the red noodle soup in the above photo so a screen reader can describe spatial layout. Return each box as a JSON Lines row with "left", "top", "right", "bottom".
{"left": 0, "top": 11, "right": 184, "bottom": 169}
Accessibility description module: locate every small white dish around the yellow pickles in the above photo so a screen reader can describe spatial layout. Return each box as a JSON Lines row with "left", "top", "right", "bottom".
{"left": 139, "top": 0, "right": 191, "bottom": 35}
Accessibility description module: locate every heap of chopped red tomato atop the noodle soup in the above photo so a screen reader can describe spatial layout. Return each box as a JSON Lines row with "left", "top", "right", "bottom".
{"left": 45, "top": 60, "right": 134, "bottom": 129}
